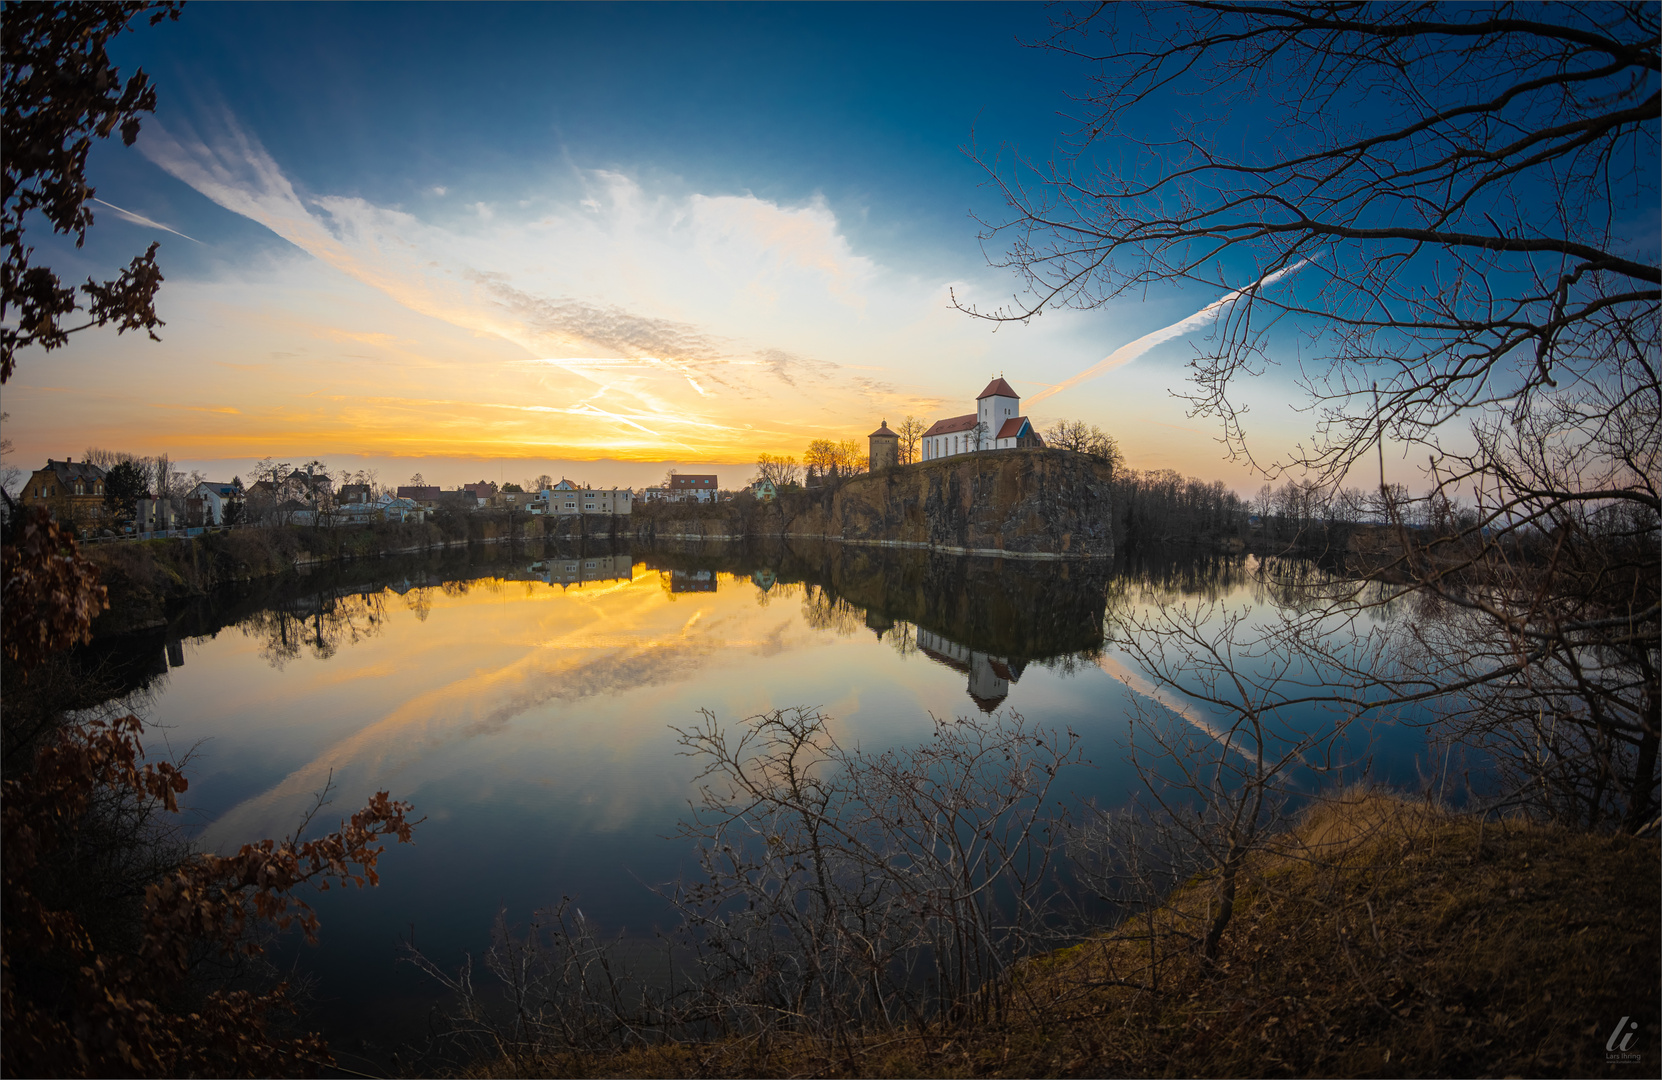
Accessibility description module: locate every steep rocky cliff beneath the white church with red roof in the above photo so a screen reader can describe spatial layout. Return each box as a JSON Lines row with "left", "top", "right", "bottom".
{"left": 784, "top": 450, "right": 1114, "bottom": 558}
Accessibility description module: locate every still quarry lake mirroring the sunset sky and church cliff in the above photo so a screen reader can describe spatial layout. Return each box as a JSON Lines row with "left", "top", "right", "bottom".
{"left": 93, "top": 545, "right": 1431, "bottom": 1052}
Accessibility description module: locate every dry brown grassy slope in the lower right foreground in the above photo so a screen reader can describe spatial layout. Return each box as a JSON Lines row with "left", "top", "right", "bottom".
{"left": 467, "top": 793, "right": 1662, "bottom": 1077}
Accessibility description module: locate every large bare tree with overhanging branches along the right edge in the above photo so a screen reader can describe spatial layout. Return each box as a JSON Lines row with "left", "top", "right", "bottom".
{"left": 966, "top": 0, "right": 1662, "bottom": 829}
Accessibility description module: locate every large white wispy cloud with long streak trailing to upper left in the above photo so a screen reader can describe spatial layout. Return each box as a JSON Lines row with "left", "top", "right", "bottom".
{"left": 141, "top": 116, "right": 937, "bottom": 450}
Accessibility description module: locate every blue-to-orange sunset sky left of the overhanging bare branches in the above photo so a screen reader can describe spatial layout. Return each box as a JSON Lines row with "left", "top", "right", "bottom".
{"left": 3, "top": 3, "right": 1308, "bottom": 490}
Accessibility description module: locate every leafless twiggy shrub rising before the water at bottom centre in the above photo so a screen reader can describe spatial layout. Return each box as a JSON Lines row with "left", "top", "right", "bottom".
{"left": 400, "top": 709, "right": 1080, "bottom": 1062}
